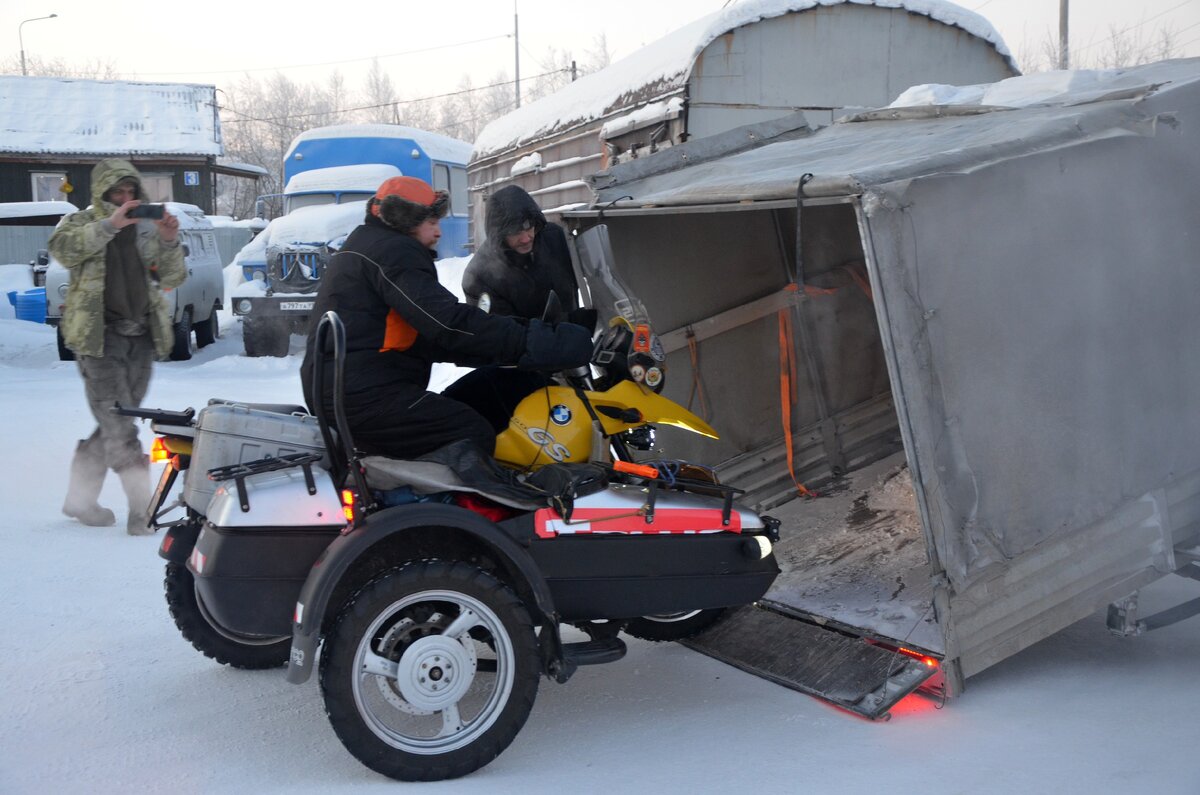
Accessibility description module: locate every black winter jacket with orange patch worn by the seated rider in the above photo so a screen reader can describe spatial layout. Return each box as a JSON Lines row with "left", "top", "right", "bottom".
{"left": 301, "top": 217, "right": 527, "bottom": 407}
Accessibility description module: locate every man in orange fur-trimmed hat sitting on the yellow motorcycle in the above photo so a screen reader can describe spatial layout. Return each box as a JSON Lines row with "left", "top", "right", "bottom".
{"left": 300, "top": 177, "right": 592, "bottom": 459}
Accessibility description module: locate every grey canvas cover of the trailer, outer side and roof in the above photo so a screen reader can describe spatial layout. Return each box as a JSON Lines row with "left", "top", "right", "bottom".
{"left": 593, "top": 59, "right": 1200, "bottom": 691}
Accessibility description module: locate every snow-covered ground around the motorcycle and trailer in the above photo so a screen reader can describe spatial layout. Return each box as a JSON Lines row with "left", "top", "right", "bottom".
{"left": 0, "top": 265, "right": 1200, "bottom": 795}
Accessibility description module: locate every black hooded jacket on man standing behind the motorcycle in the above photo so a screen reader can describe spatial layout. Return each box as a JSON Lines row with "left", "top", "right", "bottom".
{"left": 462, "top": 185, "right": 578, "bottom": 318}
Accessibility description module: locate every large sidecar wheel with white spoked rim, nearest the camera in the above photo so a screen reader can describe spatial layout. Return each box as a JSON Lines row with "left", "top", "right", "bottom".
{"left": 320, "top": 560, "right": 541, "bottom": 781}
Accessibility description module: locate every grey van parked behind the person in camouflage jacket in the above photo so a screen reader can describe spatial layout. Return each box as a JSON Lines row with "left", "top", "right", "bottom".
{"left": 46, "top": 202, "right": 224, "bottom": 361}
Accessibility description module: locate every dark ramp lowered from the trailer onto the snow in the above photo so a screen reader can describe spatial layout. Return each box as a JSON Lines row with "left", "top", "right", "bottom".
{"left": 682, "top": 605, "right": 937, "bottom": 721}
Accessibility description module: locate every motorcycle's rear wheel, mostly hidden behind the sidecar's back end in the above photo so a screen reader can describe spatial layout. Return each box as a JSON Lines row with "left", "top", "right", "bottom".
{"left": 162, "top": 563, "right": 292, "bottom": 670}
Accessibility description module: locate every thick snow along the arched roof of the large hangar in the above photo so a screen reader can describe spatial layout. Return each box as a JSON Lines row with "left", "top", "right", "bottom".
{"left": 474, "top": 0, "right": 1016, "bottom": 160}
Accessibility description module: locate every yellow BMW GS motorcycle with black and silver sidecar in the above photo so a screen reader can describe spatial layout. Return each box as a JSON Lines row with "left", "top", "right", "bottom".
{"left": 125, "top": 225, "right": 779, "bottom": 781}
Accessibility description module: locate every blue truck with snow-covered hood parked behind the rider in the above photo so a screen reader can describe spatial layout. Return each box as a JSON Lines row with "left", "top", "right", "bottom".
{"left": 234, "top": 125, "right": 470, "bottom": 357}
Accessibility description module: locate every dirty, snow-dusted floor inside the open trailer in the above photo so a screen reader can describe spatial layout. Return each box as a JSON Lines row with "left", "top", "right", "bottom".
{"left": 761, "top": 453, "right": 944, "bottom": 654}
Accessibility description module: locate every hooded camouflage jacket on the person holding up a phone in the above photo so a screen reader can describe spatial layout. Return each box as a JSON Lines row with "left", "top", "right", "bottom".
{"left": 48, "top": 160, "right": 187, "bottom": 358}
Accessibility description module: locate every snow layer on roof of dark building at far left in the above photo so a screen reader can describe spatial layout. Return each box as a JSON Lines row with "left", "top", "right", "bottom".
{"left": 0, "top": 74, "right": 222, "bottom": 155}
